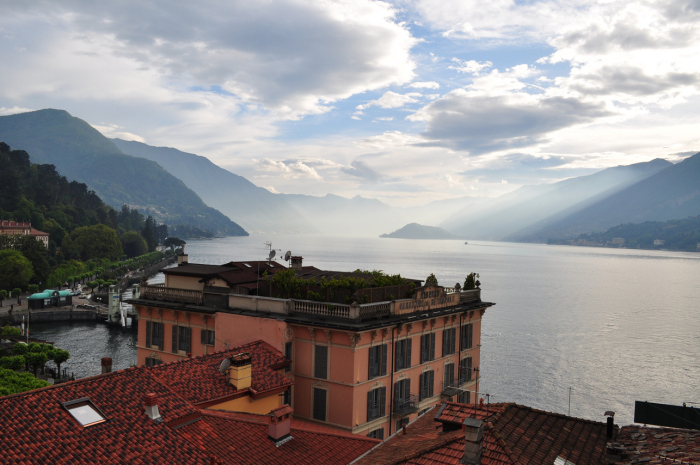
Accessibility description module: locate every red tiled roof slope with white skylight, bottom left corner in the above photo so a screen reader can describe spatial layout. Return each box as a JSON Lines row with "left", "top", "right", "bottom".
{"left": 0, "top": 368, "right": 210, "bottom": 464}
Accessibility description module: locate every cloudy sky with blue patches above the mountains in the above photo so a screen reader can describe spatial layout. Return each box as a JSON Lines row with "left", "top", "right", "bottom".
{"left": 0, "top": 0, "right": 700, "bottom": 206}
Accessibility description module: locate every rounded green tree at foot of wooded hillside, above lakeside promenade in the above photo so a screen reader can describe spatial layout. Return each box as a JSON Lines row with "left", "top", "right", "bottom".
{"left": 61, "top": 224, "right": 123, "bottom": 261}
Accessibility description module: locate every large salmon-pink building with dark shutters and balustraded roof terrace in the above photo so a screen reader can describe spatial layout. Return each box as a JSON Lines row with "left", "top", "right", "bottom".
{"left": 130, "top": 248, "right": 493, "bottom": 439}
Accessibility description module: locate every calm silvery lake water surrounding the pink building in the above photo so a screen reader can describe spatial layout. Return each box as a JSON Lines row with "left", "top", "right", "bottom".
{"left": 33, "top": 235, "right": 700, "bottom": 424}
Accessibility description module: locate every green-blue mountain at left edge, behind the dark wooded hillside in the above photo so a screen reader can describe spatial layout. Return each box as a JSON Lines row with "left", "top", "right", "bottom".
{"left": 0, "top": 109, "right": 248, "bottom": 236}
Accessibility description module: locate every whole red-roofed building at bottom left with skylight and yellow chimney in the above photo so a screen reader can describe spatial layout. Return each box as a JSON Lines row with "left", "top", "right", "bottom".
{"left": 0, "top": 341, "right": 379, "bottom": 465}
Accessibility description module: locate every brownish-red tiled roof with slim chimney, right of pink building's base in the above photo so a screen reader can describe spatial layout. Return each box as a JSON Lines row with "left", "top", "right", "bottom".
{"left": 353, "top": 402, "right": 607, "bottom": 465}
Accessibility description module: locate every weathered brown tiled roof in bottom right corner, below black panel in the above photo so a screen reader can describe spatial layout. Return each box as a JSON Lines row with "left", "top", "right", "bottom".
{"left": 615, "top": 425, "right": 700, "bottom": 465}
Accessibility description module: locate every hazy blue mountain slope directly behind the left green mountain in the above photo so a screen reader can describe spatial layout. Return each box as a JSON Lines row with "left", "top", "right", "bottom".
{"left": 112, "top": 139, "right": 316, "bottom": 233}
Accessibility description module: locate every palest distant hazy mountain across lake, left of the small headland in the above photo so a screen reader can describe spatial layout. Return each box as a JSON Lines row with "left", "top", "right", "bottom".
{"left": 277, "top": 194, "right": 406, "bottom": 237}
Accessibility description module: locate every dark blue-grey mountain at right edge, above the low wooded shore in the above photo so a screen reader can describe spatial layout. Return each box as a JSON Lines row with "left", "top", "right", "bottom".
{"left": 538, "top": 153, "right": 700, "bottom": 238}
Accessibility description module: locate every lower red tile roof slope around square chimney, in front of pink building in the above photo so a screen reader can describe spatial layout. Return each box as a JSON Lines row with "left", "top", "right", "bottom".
{"left": 178, "top": 410, "right": 379, "bottom": 465}
